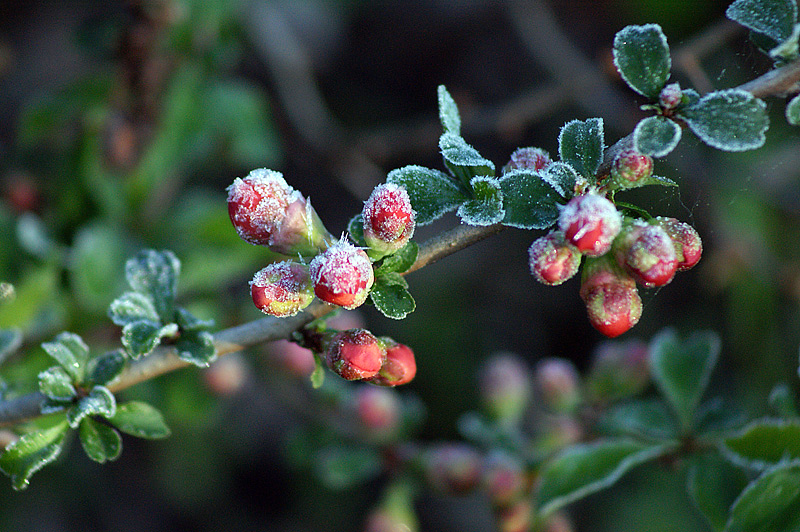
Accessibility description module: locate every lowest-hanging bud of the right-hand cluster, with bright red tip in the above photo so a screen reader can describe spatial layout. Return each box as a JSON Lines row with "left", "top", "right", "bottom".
{"left": 580, "top": 257, "right": 642, "bottom": 338}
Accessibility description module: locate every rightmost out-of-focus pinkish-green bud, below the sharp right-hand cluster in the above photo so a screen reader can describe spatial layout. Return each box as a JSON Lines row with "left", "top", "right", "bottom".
{"left": 586, "top": 339, "right": 650, "bottom": 402}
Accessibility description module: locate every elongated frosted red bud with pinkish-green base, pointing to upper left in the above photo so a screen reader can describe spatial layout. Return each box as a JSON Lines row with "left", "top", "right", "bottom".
{"left": 227, "top": 168, "right": 332, "bottom": 257}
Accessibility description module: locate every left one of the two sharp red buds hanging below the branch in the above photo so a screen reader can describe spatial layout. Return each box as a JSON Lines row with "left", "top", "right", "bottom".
{"left": 325, "top": 329, "right": 386, "bottom": 381}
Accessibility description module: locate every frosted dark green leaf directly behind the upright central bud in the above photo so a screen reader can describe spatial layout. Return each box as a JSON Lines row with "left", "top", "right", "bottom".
{"left": 386, "top": 165, "right": 468, "bottom": 225}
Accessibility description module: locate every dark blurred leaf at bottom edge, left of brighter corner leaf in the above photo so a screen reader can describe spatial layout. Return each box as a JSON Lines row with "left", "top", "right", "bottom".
{"left": 686, "top": 453, "right": 747, "bottom": 532}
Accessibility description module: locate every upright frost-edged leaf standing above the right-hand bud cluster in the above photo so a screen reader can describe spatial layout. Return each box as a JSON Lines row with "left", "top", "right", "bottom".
{"left": 558, "top": 118, "right": 605, "bottom": 178}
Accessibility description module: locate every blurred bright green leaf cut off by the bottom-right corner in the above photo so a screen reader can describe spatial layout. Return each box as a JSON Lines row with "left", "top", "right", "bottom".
{"left": 725, "top": 461, "right": 800, "bottom": 532}
